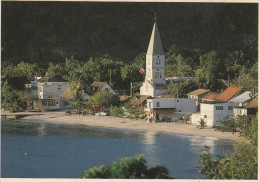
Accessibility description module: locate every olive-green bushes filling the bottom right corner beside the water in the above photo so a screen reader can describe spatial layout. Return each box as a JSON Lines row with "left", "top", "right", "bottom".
{"left": 200, "top": 116, "right": 258, "bottom": 179}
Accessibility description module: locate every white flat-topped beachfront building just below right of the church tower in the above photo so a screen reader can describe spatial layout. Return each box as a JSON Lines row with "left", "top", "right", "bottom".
{"left": 145, "top": 98, "right": 196, "bottom": 121}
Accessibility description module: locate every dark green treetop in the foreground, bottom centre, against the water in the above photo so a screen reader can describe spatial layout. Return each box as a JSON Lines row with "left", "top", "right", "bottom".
{"left": 80, "top": 155, "right": 171, "bottom": 179}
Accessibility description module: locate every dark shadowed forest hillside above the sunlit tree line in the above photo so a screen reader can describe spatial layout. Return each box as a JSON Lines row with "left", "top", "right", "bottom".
{"left": 1, "top": 2, "right": 258, "bottom": 66}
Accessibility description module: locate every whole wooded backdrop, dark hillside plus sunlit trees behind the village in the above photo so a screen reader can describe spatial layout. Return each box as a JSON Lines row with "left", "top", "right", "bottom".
{"left": 1, "top": 2, "right": 258, "bottom": 101}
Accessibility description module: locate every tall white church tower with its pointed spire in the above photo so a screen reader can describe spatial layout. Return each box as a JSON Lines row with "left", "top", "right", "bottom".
{"left": 140, "top": 18, "right": 169, "bottom": 97}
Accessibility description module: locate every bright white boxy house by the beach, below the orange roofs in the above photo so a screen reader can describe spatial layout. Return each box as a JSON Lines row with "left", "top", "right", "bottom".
{"left": 191, "top": 102, "right": 238, "bottom": 127}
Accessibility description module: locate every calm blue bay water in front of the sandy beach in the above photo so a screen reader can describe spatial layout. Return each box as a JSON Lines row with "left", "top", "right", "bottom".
{"left": 1, "top": 120, "right": 234, "bottom": 179}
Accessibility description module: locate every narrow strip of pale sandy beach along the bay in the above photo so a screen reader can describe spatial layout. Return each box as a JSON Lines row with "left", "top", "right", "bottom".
{"left": 2, "top": 112, "right": 244, "bottom": 142}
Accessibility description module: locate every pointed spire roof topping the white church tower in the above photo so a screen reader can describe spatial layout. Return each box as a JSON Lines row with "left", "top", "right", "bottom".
{"left": 146, "top": 22, "right": 164, "bottom": 55}
